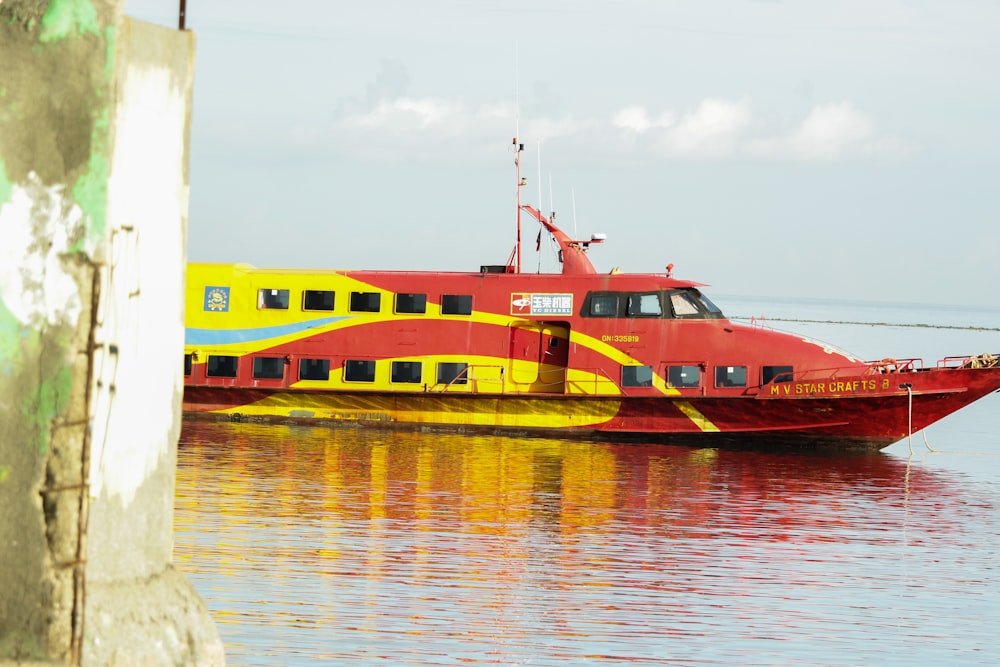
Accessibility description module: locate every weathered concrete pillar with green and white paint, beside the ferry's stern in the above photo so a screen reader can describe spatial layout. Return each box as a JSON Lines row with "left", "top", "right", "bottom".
{"left": 0, "top": 0, "right": 223, "bottom": 665}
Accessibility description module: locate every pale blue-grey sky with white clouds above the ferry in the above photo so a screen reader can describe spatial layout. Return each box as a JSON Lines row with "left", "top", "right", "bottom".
{"left": 125, "top": 0, "right": 1000, "bottom": 309}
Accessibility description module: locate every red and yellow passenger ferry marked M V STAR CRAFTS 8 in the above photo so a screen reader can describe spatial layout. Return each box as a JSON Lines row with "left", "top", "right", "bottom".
{"left": 184, "top": 140, "right": 1000, "bottom": 449}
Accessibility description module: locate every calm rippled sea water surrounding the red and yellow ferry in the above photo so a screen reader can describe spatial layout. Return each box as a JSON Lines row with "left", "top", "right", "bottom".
{"left": 175, "top": 302, "right": 1000, "bottom": 665}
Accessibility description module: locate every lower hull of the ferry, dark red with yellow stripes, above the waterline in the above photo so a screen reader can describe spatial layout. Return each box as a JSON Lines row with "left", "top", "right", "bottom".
{"left": 184, "top": 368, "right": 1000, "bottom": 450}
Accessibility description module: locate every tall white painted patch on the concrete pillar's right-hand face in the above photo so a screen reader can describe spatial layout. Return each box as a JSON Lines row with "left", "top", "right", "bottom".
{"left": 90, "top": 26, "right": 190, "bottom": 506}
